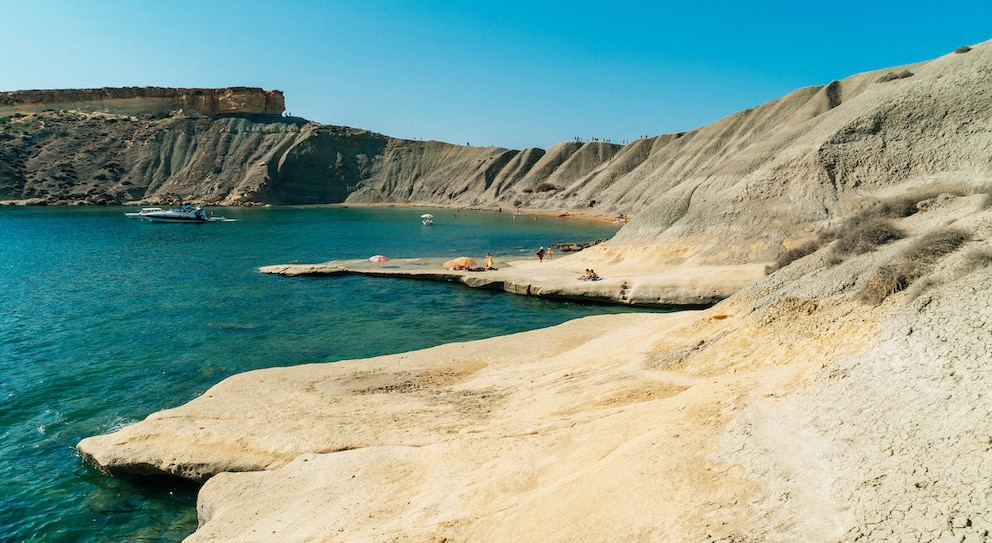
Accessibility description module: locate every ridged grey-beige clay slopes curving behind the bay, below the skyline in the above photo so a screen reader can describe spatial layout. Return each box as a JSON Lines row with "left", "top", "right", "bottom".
{"left": 0, "top": 43, "right": 992, "bottom": 263}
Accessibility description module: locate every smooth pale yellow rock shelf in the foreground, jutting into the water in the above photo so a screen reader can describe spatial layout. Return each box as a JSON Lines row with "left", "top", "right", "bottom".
{"left": 80, "top": 288, "right": 876, "bottom": 542}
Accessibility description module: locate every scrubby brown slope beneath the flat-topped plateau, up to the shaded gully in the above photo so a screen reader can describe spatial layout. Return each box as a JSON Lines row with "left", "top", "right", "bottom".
{"left": 0, "top": 111, "right": 304, "bottom": 204}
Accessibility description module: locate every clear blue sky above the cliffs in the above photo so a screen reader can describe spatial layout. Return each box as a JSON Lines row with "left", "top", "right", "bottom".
{"left": 0, "top": 0, "right": 992, "bottom": 149}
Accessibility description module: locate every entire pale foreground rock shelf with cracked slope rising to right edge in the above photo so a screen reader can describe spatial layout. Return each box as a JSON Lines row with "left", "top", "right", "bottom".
{"left": 79, "top": 188, "right": 992, "bottom": 543}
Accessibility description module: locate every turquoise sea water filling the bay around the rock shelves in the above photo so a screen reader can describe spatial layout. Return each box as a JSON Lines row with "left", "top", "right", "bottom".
{"left": 0, "top": 207, "right": 656, "bottom": 542}
